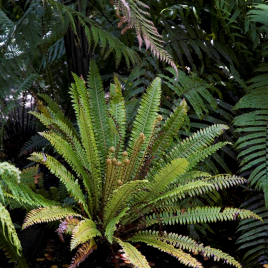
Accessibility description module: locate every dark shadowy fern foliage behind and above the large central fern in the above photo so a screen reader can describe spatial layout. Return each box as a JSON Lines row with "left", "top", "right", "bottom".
{"left": 0, "top": 0, "right": 268, "bottom": 267}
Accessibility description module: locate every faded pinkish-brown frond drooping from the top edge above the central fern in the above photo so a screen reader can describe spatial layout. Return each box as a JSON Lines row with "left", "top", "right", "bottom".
{"left": 111, "top": 0, "right": 178, "bottom": 75}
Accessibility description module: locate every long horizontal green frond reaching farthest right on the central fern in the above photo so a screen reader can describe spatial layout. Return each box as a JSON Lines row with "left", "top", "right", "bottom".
{"left": 144, "top": 207, "right": 262, "bottom": 226}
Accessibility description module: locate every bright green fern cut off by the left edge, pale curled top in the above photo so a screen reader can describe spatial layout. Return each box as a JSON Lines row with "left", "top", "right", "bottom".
{"left": 0, "top": 162, "right": 56, "bottom": 268}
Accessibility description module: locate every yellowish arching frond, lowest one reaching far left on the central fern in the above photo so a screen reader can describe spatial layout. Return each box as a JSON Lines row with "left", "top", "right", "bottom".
{"left": 22, "top": 206, "right": 82, "bottom": 229}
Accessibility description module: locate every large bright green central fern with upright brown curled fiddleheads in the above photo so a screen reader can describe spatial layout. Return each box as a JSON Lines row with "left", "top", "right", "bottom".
{"left": 23, "top": 61, "right": 260, "bottom": 268}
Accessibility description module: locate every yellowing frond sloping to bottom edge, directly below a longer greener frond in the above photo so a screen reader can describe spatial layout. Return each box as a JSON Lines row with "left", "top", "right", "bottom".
{"left": 130, "top": 235, "right": 203, "bottom": 268}
